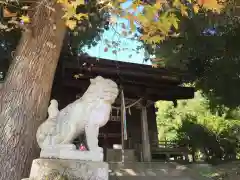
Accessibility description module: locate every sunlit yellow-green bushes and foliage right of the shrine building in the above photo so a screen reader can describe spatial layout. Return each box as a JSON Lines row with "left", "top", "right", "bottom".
{"left": 156, "top": 91, "right": 240, "bottom": 161}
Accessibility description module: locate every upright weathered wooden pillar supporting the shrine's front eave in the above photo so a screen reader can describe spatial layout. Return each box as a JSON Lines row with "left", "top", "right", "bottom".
{"left": 141, "top": 103, "right": 152, "bottom": 162}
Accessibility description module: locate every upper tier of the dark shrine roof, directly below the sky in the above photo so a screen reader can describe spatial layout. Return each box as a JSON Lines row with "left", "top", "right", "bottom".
{"left": 62, "top": 56, "right": 191, "bottom": 84}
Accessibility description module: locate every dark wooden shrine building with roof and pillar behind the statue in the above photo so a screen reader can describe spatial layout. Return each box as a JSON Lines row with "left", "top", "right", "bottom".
{"left": 52, "top": 56, "right": 194, "bottom": 162}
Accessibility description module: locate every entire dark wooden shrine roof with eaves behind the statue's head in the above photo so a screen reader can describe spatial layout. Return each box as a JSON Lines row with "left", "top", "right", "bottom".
{"left": 59, "top": 56, "right": 194, "bottom": 101}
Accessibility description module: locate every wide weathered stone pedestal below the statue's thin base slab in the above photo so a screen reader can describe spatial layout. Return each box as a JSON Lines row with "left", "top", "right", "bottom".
{"left": 22, "top": 159, "right": 108, "bottom": 180}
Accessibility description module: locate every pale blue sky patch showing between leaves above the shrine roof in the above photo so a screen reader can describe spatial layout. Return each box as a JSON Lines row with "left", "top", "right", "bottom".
{"left": 81, "top": 1, "right": 151, "bottom": 65}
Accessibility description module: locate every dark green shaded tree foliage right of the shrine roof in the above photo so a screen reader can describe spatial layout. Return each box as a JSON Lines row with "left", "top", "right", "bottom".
{"left": 142, "top": 1, "right": 240, "bottom": 108}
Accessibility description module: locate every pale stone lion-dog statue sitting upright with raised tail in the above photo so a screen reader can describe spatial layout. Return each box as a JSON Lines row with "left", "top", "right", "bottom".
{"left": 36, "top": 76, "right": 119, "bottom": 151}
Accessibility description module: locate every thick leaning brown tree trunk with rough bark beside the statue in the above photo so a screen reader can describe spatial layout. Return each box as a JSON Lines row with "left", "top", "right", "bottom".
{"left": 0, "top": 1, "right": 66, "bottom": 180}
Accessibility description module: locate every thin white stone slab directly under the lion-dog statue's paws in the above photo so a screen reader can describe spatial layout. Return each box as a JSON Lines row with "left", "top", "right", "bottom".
{"left": 40, "top": 144, "right": 103, "bottom": 161}
